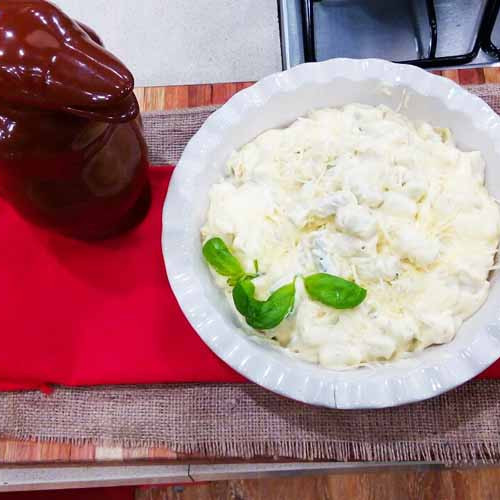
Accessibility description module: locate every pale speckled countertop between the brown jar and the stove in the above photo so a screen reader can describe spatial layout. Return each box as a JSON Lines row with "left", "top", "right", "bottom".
{"left": 52, "top": 0, "right": 281, "bottom": 86}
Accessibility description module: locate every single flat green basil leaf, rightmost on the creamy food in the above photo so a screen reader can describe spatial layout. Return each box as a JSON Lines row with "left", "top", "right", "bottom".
{"left": 304, "top": 273, "right": 367, "bottom": 309}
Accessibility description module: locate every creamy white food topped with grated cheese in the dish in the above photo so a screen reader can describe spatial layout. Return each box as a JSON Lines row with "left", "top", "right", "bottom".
{"left": 202, "top": 104, "right": 500, "bottom": 369}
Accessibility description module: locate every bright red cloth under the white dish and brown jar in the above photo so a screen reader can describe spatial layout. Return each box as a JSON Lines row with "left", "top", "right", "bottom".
{"left": 0, "top": 167, "right": 500, "bottom": 390}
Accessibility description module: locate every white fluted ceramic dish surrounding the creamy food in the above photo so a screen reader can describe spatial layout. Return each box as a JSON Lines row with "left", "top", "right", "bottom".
{"left": 162, "top": 59, "right": 500, "bottom": 408}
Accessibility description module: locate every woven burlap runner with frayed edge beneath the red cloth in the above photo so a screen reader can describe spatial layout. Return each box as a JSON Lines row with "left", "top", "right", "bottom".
{"left": 0, "top": 85, "right": 500, "bottom": 464}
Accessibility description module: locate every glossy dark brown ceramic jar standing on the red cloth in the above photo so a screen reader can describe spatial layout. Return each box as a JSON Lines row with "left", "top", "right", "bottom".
{"left": 0, "top": 0, "right": 149, "bottom": 239}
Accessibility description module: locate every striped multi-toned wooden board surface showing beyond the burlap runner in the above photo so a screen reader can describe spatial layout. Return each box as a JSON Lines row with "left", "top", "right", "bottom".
{"left": 0, "top": 68, "right": 500, "bottom": 464}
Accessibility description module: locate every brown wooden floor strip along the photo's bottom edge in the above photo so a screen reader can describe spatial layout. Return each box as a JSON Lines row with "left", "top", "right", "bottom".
{"left": 135, "top": 468, "right": 500, "bottom": 500}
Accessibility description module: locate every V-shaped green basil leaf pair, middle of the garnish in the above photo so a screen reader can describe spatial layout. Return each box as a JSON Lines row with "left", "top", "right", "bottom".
{"left": 233, "top": 278, "right": 295, "bottom": 330}
